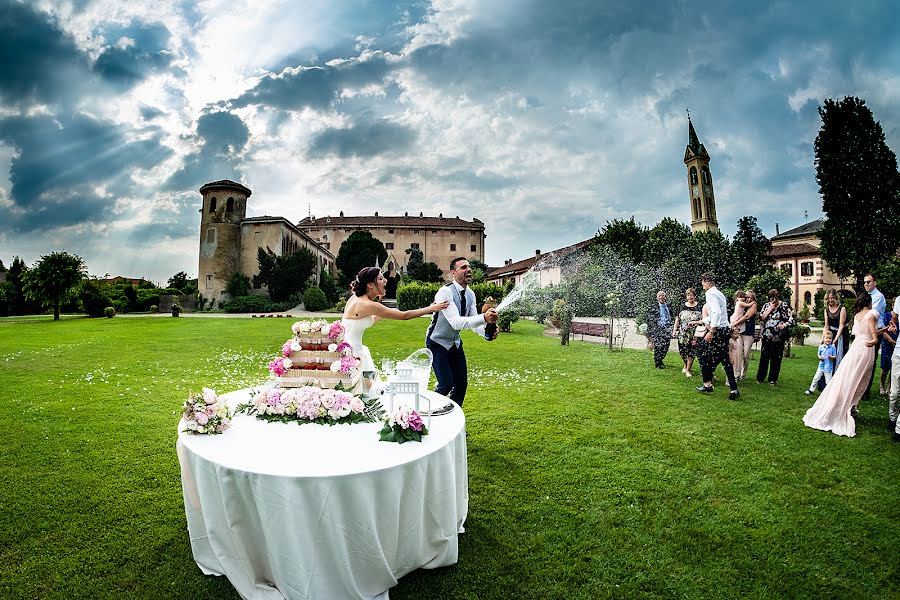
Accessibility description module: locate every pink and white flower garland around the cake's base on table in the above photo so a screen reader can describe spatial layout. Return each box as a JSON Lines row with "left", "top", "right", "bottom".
{"left": 234, "top": 386, "right": 384, "bottom": 425}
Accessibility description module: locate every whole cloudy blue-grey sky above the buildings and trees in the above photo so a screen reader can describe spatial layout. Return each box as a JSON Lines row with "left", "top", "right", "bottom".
{"left": 0, "top": 0, "right": 900, "bottom": 281}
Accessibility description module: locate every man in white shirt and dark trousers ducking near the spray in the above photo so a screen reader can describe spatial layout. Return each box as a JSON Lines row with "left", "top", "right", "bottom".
{"left": 697, "top": 273, "right": 741, "bottom": 400}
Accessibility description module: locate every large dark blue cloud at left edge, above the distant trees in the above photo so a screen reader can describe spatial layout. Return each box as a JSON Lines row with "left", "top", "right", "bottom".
{"left": 0, "top": 115, "right": 171, "bottom": 232}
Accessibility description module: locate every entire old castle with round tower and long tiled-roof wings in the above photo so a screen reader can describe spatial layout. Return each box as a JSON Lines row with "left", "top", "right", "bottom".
{"left": 197, "top": 179, "right": 487, "bottom": 304}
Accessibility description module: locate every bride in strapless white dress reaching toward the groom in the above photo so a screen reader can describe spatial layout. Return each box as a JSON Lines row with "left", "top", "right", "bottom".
{"left": 341, "top": 267, "right": 449, "bottom": 375}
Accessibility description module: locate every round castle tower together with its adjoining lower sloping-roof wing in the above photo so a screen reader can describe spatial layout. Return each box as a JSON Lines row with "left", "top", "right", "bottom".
{"left": 197, "top": 179, "right": 334, "bottom": 304}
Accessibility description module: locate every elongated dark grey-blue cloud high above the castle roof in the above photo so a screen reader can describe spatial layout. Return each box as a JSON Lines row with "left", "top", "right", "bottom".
{"left": 228, "top": 53, "right": 392, "bottom": 110}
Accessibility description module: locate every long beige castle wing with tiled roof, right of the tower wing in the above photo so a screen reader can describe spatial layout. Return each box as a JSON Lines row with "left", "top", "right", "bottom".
{"left": 297, "top": 212, "right": 487, "bottom": 276}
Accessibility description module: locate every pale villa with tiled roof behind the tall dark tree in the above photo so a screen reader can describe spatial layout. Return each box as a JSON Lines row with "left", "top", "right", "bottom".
{"left": 769, "top": 218, "right": 848, "bottom": 310}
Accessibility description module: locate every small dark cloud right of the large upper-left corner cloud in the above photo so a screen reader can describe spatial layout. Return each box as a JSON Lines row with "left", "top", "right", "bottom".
{"left": 93, "top": 23, "right": 172, "bottom": 89}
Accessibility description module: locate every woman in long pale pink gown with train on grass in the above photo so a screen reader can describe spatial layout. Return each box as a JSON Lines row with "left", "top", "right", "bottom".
{"left": 803, "top": 292, "right": 881, "bottom": 437}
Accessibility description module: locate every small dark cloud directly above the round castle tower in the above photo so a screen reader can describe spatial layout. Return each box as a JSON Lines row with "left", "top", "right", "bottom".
{"left": 165, "top": 112, "right": 250, "bottom": 190}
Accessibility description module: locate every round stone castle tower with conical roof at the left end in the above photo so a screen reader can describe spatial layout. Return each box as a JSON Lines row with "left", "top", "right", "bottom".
{"left": 197, "top": 179, "right": 252, "bottom": 306}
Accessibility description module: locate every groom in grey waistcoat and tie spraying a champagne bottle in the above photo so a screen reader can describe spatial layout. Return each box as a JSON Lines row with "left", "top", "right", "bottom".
{"left": 425, "top": 257, "right": 497, "bottom": 406}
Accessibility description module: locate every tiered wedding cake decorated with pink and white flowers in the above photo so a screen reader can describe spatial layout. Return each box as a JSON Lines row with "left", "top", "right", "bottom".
{"left": 268, "top": 319, "right": 362, "bottom": 391}
